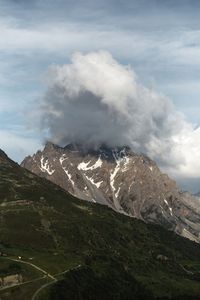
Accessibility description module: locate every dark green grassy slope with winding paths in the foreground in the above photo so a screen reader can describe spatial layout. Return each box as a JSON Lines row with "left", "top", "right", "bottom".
{"left": 0, "top": 152, "right": 200, "bottom": 300}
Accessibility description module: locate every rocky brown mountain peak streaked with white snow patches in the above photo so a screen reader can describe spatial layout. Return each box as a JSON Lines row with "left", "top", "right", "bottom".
{"left": 21, "top": 143, "right": 200, "bottom": 242}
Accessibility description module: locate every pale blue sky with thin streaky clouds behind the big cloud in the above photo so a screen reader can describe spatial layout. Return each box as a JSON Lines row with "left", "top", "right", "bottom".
{"left": 0, "top": 0, "right": 200, "bottom": 192}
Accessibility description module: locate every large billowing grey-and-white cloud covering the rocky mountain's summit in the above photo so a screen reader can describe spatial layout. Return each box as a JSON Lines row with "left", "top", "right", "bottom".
{"left": 38, "top": 51, "right": 200, "bottom": 177}
